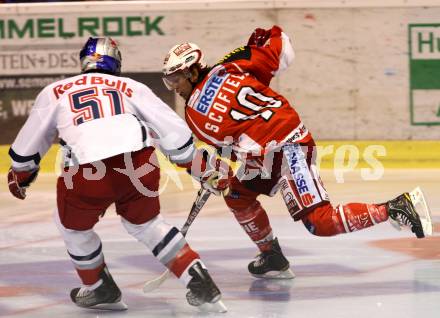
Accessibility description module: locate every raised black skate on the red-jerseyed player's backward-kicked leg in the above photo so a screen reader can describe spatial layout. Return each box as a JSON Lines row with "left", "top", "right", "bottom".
{"left": 386, "top": 187, "right": 432, "bottom": 238}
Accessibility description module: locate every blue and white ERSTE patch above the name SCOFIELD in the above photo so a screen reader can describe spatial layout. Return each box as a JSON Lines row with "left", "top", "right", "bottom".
{"left": 188, "top": 72, "right": 229, "bottom": 116}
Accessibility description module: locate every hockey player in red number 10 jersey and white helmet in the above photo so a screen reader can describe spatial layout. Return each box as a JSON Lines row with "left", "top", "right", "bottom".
{"left": 163, "top": 26, "right": 431, "bottom": 278}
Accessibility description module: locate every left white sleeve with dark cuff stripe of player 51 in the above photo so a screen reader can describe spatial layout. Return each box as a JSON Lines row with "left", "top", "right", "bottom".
{"left": 9, "top": 88, "right": 56, "bottom": 171}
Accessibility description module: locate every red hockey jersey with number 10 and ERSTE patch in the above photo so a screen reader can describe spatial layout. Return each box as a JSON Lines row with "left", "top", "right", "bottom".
{"left": 185, "top": 26, "right": 312, "bottom": 156}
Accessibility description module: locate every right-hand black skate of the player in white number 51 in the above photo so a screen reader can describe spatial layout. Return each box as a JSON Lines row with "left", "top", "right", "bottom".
{"left": 186, "top": 262, "right": 227, "bottom": 312}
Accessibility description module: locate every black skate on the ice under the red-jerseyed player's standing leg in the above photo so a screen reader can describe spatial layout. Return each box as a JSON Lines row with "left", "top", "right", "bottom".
{"left": 248, "top": 238, "right": 295, "bottom": 279}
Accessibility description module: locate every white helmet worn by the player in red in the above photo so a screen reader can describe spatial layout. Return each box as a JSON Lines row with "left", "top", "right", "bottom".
{"left": 162, "top": 42, "right": 207, "bottom": 76}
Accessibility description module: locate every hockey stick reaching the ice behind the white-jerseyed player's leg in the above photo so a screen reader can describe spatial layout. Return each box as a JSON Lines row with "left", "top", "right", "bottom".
{"left": 143, "top": 188, "right": 211, "bottom": 293}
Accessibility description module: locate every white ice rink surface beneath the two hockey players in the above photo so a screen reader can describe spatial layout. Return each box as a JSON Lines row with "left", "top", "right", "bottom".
{"left": 0, "top": 170, "right": 440, "bottom": 318}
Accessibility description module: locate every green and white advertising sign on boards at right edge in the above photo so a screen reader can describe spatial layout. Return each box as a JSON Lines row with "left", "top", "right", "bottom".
{"left": 408, "top": 24, "right": 440, "bottom": 126}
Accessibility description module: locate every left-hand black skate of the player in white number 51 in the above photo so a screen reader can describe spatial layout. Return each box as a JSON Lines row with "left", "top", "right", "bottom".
{"left": 70, "top": 266, "right": 127, "bottom": 310}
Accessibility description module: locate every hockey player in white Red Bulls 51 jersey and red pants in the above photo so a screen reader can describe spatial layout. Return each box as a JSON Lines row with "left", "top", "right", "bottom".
{"left": 8, "top": 38, "right": 225, "bottom": 310}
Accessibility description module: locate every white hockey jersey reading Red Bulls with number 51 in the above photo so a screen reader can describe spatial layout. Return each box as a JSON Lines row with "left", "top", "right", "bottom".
{"left": 9, "top": 73, "right": 194, "bottom": 170}
